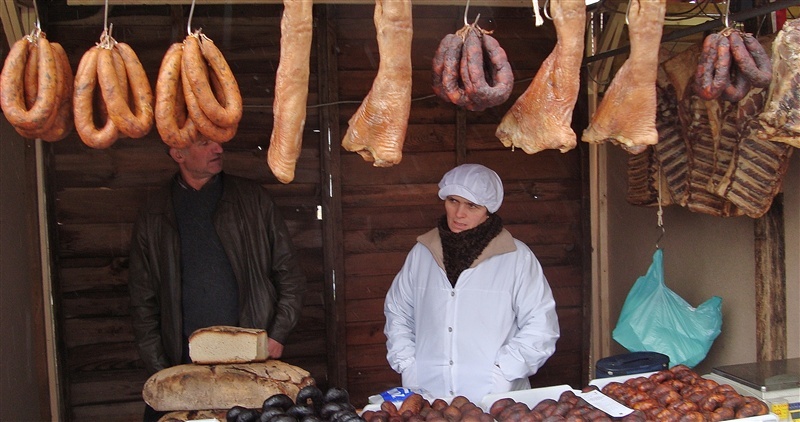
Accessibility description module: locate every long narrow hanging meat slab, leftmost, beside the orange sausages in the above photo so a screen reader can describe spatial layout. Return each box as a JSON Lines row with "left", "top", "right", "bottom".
{"left": 267, "top": 0, "right": 314, "bottom": 183}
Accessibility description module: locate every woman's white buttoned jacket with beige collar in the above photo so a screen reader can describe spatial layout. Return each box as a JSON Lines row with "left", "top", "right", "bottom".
{"left": 384, "top": 229, "right": 559, "bottom": 403}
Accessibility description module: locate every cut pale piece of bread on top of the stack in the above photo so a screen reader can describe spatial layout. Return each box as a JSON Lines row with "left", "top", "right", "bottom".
{"left": 189, "top": 325, "right": 269, "bottom": 364}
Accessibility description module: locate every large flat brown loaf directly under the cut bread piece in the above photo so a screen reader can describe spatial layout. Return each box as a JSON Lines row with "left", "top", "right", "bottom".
{"left": 142, "top": 359, "right": 314, "bottom": 412}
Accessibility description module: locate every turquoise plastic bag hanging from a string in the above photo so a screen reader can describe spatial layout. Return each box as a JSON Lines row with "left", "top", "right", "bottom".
{"left": 612, "top": 249, "right": 722, "bottom": 368}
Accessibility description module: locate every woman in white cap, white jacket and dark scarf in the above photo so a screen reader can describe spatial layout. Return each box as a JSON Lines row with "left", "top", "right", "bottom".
{"left": 384, "top": 164, "right": 559, "bottom": 403}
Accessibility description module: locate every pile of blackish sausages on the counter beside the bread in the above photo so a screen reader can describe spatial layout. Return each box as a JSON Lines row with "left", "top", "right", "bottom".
{"left": 225, "top": 385, "right": 364, "bottom": 422}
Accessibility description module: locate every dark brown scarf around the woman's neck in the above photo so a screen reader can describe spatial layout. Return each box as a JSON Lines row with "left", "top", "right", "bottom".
{"left": 439, "top": 214, "right": 503, "bottom": 287}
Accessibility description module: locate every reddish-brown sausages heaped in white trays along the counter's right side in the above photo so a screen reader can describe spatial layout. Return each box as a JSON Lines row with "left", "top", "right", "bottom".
{"left": 362, "top": 365, "right": 769, "bottom": 422}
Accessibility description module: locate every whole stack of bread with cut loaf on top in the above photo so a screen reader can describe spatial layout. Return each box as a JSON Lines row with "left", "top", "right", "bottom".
{"left": 142, "top": 326, "right": 314, "bottom": 421}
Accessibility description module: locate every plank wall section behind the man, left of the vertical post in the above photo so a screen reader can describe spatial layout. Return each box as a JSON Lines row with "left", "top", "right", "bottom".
{"left": 45, "top": 5, "right": 327, "bottom": 421}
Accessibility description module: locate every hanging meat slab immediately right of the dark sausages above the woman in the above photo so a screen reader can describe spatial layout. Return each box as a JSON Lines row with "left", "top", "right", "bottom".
{"left": 495, "top": 0, "right": 586, "bottom": 154}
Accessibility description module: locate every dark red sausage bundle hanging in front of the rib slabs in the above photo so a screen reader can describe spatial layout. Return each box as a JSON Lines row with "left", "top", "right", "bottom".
{"left": 694, "top": 28, "right": 772, "bottom": 103}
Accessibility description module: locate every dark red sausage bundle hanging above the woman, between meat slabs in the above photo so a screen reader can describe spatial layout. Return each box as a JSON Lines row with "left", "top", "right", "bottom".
{"left": 433, "top": 20, "right": 514, "bottom": 111}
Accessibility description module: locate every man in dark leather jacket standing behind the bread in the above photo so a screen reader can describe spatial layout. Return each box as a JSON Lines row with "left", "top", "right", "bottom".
{"left": 129, "top": 139, "right": 305, "bottom": 420}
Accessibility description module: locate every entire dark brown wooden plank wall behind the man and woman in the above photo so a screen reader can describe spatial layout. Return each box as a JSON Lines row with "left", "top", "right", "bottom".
{"left": 40, "top": 1, "right": 589, "bottom": 421}
